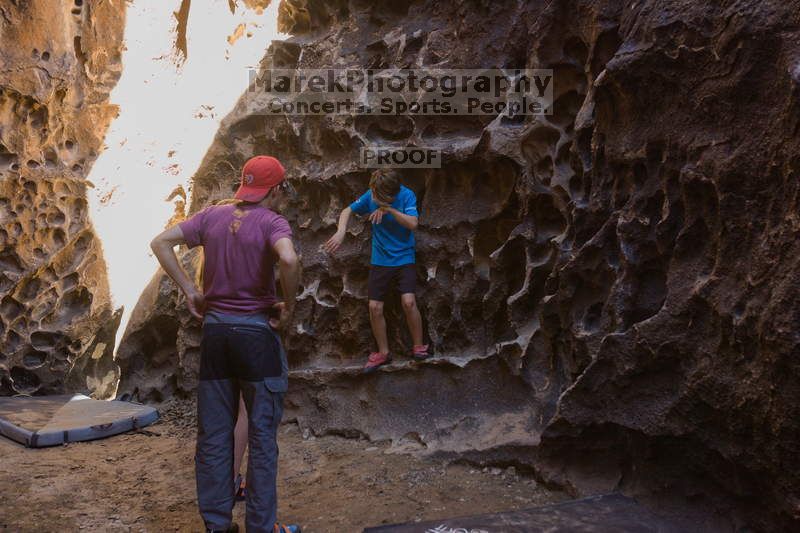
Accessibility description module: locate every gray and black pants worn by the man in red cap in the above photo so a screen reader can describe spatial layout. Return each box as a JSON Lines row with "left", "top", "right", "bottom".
{"left": 195, "top": 313, "right": 288, "bottom": 532}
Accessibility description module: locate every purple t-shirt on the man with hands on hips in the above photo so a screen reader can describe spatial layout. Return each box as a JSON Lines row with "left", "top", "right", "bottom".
{"left": 178, "top": 204, "right": 292, "bottom": 314}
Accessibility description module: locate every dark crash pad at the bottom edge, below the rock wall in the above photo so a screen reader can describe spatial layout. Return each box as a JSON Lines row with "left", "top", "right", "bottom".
{"left": 364, "top": 494, "right": 686, "bottom": 533}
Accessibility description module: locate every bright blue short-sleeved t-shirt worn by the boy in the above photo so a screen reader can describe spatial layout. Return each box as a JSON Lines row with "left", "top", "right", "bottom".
{"left": 350, "top": 185, "right": 419, "bottom": 266}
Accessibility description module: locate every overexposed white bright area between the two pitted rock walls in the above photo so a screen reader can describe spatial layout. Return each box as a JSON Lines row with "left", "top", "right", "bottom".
{"left": 88, "top": 0, "right": 286, "bottom": 354}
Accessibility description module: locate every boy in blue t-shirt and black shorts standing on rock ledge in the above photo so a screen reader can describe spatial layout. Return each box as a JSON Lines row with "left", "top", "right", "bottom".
{"left": 325, "top": 170, "right": 430, "bottom": 372}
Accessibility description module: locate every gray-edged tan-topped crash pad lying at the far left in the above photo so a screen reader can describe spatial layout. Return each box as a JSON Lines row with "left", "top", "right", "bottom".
{"left": 0, "top": 394, "right": 158, "bottom": 448}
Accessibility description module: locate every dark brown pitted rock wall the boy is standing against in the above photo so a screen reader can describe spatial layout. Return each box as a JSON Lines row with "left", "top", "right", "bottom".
{"left": 119, "top": 0, "right": 800, "bottom": 530}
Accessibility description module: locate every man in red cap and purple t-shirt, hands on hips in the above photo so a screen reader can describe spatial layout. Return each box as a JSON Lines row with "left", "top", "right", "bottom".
{"left": 151, "top": 156, "right": 300, "bottom": 533}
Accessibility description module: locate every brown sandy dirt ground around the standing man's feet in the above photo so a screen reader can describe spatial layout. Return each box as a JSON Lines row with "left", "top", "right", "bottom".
{"left": 0, "top": 401, "right": 566, "bottom": 533}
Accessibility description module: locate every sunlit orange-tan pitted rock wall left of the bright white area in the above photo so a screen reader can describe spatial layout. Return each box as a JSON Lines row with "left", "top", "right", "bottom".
{"left": 0, "top": 0, "right": 125, "bottom": 396}
